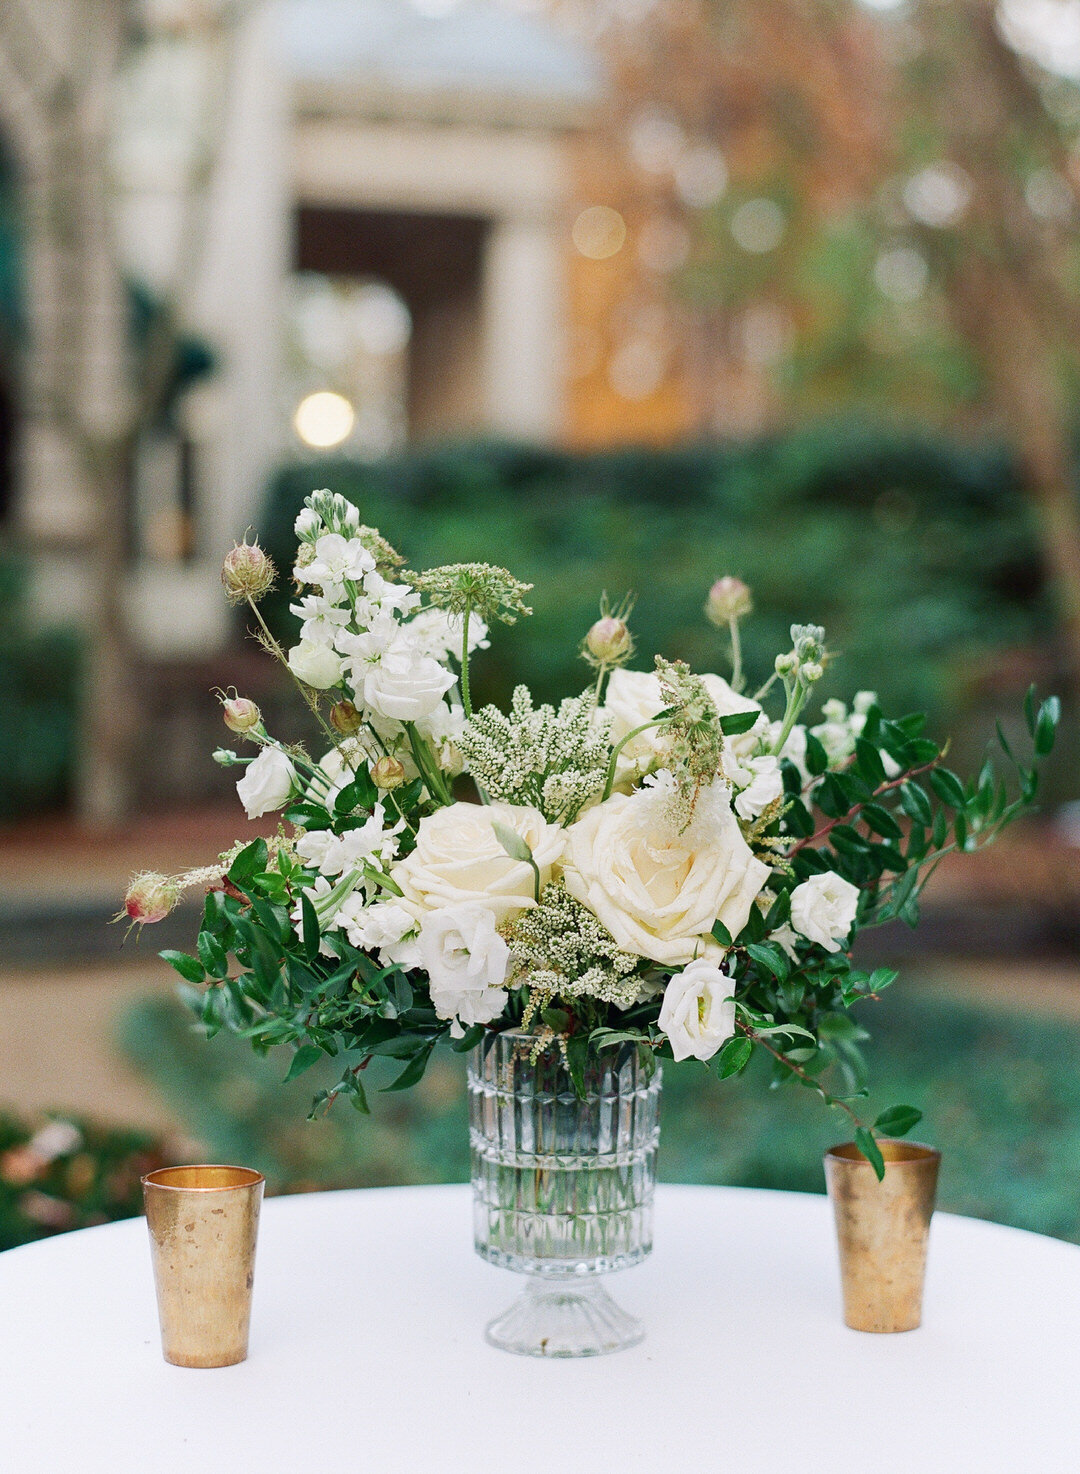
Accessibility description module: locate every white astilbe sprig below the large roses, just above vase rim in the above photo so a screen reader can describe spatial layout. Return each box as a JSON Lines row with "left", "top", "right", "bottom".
{"left": 502, "top": 880, "right": 642, "bottom": 1013}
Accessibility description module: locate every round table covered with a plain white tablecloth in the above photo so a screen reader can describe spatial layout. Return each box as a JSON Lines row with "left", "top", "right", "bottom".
{"left": 0, "top": 1187, "right": 1080, "bottom": 1474}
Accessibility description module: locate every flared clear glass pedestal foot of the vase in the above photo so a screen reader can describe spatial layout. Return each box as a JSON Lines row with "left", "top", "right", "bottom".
{"left": 485, "top": 1275, "right": 645, "bottom": 1356}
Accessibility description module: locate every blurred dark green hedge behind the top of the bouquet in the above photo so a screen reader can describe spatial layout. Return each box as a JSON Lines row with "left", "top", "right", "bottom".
{"left": 262, "top": 425, "right": 1049, "bottom": 715}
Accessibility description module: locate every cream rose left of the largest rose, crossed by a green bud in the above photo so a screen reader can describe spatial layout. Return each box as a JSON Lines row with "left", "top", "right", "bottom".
{"left": 390, "top": 803, "right": 566, "bottom": 923}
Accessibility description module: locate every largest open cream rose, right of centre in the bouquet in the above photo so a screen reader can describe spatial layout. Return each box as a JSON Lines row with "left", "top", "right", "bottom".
{"left": 563, "top": 786, "right": 769, "bottom": 967}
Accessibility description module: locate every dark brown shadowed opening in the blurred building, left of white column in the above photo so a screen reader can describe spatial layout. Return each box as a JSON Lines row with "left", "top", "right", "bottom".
{"left": 293, "top": 205, "right": 488, "bottom": 439}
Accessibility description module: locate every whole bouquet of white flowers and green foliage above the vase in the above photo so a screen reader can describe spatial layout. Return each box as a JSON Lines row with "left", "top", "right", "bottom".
{"left": 125, "top": 491, "right": 1059, "bottom": 1172}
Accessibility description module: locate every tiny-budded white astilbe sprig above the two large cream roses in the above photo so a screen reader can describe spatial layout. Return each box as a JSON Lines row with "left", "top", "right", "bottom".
{"left": 458, "top": 685, "right": 611, "bottom": 824}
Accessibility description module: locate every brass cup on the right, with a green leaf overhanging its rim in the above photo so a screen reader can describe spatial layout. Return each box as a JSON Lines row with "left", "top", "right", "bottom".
{"left": 825, "top": 1139, "right": 942, "bottom": 1331}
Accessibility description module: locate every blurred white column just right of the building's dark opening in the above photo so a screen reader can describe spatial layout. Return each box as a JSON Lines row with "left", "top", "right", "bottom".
{"left": 482, "top": 217, "right": 566, "bottom": 442}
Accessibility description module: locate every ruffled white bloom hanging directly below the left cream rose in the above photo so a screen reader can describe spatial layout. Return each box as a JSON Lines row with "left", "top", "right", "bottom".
{"left": 418, "top": 902, "right": 510, "bottom": 1024}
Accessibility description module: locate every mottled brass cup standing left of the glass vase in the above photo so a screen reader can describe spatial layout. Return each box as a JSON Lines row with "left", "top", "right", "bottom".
{"left": 143, "top": 1166, "right": 265, "bottom": 1366}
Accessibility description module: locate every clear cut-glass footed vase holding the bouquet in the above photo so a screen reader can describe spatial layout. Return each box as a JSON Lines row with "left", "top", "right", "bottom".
{"left": 469, "top": 1032, "right": 662, "bottom": 1356}
